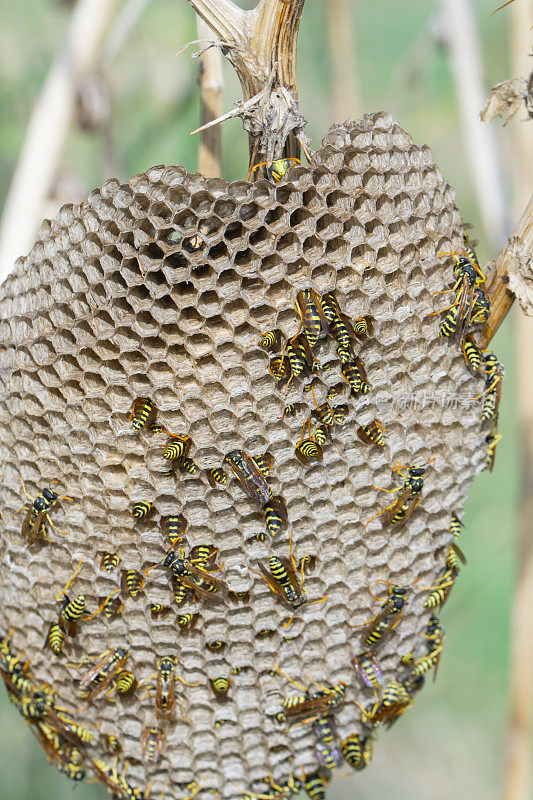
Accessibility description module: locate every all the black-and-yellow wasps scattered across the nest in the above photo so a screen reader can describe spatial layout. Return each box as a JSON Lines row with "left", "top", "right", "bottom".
{"left": 0, "top": 200, "right": 504, "bottom": 800}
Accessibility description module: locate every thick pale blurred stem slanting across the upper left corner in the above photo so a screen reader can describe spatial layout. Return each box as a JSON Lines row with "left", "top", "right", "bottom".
{"left": 0, "top": 0, "right": 117, "bottom": 280}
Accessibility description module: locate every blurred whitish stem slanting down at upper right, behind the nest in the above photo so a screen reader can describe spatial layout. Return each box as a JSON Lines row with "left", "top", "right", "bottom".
{"left": 442, "top": 0, "right": 509, "bottom": 249}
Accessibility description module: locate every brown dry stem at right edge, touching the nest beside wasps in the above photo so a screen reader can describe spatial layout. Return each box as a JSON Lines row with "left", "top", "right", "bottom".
{"left": 478, "top": 195, "right": 533, "bottom": 349}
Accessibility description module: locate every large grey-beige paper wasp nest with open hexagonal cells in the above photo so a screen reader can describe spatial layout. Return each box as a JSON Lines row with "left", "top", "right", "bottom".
{"left": 0, "top": 113, "right": 486, "bottom": 800}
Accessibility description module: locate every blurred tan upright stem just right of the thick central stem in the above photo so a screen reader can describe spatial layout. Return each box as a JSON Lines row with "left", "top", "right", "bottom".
{"left": 326, "top": 0, "right": 360, "bottom": 122}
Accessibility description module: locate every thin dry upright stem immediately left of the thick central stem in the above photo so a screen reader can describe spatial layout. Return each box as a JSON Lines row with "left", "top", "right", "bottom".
{"left": 197, "top": 17, "right": 223, "bottom": 178}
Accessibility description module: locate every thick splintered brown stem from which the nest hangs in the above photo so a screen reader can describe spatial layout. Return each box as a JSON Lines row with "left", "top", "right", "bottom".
{"left": 188, "top": 0, "right": 309, "bottom": 179}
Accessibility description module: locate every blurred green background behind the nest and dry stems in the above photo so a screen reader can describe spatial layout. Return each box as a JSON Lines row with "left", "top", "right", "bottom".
{"left": 0, "top": 0, "right": 519, "bottom": 800}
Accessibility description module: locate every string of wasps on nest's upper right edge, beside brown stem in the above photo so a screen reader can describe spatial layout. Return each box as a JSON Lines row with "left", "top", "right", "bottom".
{"left": 430, "top": 234, "right": 505, "bottom": 471}
